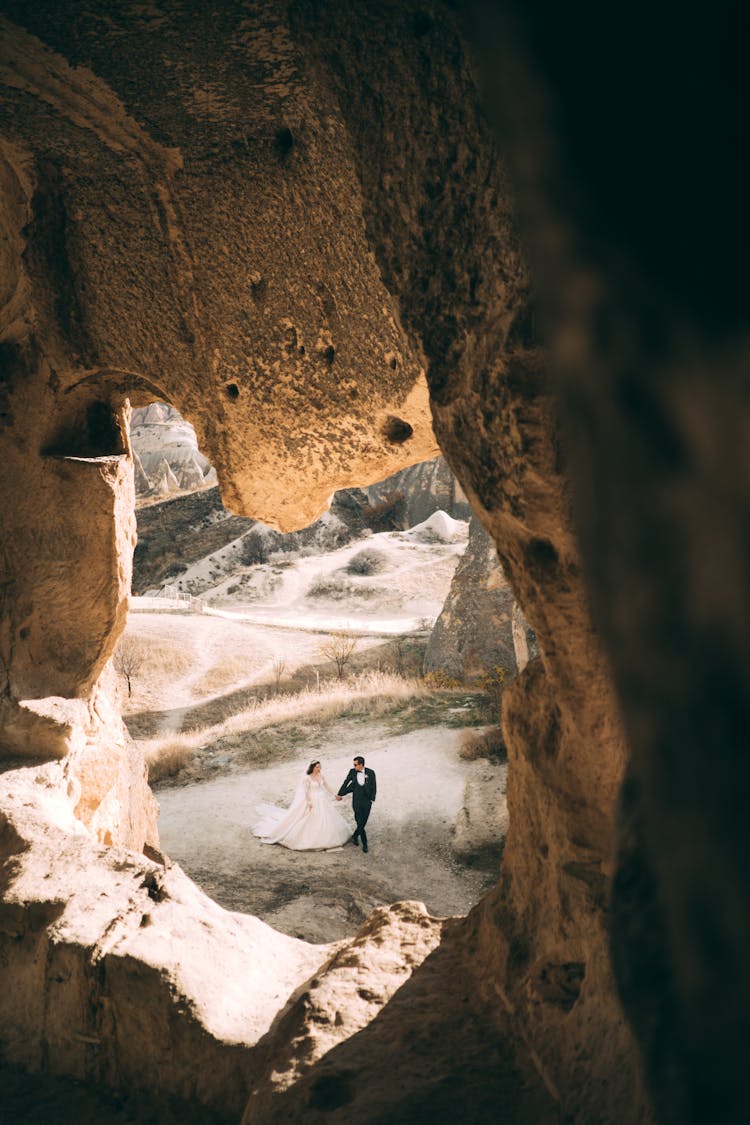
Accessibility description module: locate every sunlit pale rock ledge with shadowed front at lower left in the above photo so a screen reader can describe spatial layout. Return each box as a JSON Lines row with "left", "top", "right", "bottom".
{"left": 0, "top": 765, "right": 328, "bottom": 1115}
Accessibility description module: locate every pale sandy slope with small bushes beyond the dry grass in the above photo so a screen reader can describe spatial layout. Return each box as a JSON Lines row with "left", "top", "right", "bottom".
{"left": 125, "top": 512, "right": 467, "bottom": 730}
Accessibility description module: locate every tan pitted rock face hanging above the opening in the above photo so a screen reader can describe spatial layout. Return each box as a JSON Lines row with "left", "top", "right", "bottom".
{"left": 2, "top": 5, "right": 437, "bottom": 529}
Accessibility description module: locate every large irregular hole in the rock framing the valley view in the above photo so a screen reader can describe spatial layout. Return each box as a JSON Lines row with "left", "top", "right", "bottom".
{"left": 120, "top": 403, "right": 532, "bottom": 949}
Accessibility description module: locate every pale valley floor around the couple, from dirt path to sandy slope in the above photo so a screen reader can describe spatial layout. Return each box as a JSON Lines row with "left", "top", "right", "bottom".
{"left": 126, "top": 513, "right": 506, "bottom": 943}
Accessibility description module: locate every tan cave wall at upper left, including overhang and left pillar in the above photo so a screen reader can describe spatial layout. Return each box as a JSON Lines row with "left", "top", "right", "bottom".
{"left": 0, "top": 3, "right": 437, "bottom": 847}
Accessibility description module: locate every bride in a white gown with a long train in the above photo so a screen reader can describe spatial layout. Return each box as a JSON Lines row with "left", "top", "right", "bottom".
{"left": 253, "top": 762, "right": 352, "bottom": 852}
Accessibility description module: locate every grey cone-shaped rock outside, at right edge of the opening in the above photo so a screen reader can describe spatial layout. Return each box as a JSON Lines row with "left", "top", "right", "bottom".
{"left": 424, "top": 516, "right": 537, "bottom": 682}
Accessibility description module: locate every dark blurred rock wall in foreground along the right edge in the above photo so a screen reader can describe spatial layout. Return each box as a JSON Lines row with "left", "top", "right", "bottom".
{"left": 469, "top": 0, "right": 750, "bottom": 1123}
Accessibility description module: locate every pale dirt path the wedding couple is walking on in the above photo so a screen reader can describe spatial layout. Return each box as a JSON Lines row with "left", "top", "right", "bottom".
{"left": 156, "top": 722, "right": 501, "bottom": 942}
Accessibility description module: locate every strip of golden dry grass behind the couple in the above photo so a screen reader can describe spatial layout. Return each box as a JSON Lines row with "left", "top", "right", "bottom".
{"left": 141, "top": 672, "right": 431, "bottom": 782}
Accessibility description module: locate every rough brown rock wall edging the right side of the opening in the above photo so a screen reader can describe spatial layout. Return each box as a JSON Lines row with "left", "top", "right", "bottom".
{"left": 287, "top": 3, "right": 650, "bottom": 1121}
